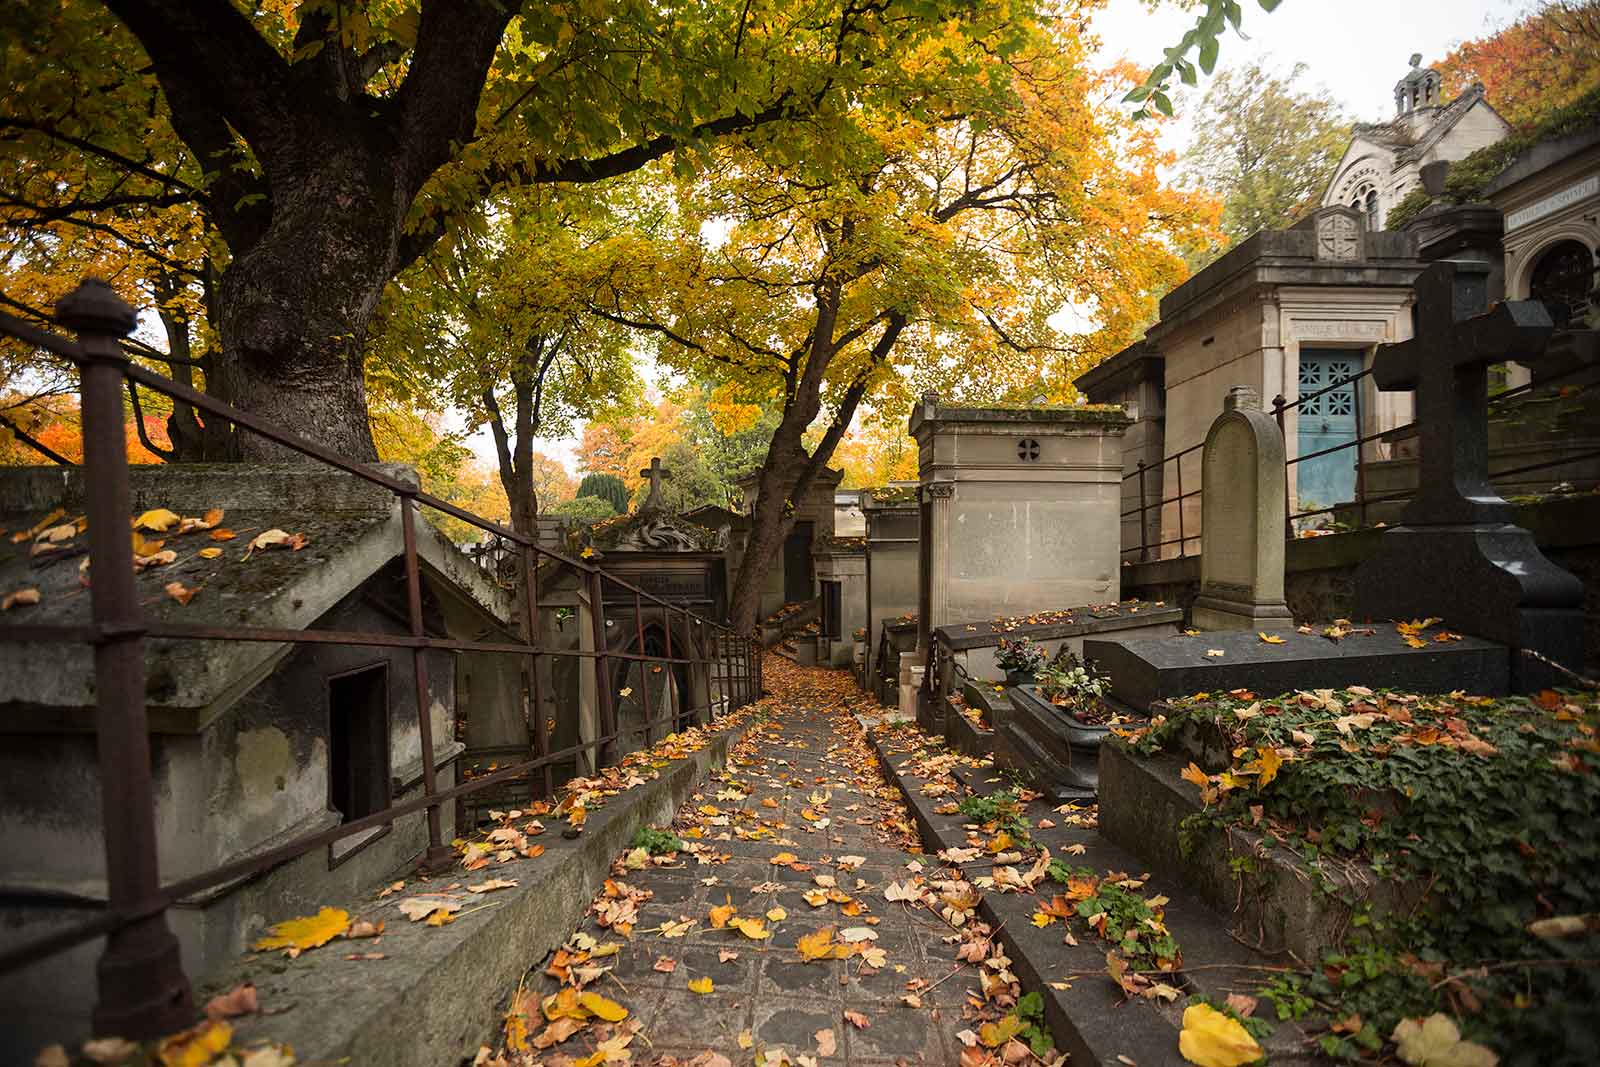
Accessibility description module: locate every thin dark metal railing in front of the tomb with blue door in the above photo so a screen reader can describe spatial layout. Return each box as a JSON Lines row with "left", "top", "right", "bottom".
{"left": 1120, "top": 351, "right": 1600, "bottom": 563}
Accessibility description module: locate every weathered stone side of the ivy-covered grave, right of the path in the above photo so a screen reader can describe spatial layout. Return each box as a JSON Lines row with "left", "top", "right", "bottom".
{"left": 1101, "top": 744, "right": 1405, "bottom": 961}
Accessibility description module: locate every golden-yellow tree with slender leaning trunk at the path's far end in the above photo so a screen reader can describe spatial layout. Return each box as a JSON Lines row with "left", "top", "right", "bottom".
{"left": 606, "top": 10, "right": 1203, "bottom": 630}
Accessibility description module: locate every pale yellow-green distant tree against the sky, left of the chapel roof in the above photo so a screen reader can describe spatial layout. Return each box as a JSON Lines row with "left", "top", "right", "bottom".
{"left": 1182, "top": 64, "right": 1350, "bottom": 254}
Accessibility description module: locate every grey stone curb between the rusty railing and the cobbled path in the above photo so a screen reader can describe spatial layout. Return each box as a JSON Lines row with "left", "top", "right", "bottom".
{"left": 214, "top": 717, "right": 749, "bottom": 1067}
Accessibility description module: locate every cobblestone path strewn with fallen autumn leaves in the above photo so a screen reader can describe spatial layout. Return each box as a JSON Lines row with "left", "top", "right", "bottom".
{"left": 478, "top": 656, "right": 1056, "bottom": 1067}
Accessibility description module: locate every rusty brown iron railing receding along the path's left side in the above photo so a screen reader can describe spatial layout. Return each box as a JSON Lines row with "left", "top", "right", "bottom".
{"left": 0, "top": 280, "right": 762, "bottom": 1038}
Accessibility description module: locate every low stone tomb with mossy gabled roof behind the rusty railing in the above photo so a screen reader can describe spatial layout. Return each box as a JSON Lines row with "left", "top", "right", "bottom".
{"left": 0, "top": 464, "right": 512, "bottom": 1062}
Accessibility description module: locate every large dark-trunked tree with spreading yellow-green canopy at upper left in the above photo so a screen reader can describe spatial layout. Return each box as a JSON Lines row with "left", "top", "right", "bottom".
{"left": 0, "top": 0, "right": 1043, "bottom": 459}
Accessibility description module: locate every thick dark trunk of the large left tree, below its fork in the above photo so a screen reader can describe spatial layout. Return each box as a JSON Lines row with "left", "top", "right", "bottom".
{"left": 213, "top": 142, "right": 393, "bottom": 461}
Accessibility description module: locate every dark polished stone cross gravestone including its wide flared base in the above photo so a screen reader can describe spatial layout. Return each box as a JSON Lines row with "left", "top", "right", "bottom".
{"left": 1355, "top": 259, "right": 1584, "bottom": 691}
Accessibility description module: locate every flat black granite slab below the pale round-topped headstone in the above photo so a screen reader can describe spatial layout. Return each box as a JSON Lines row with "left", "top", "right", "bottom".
{"left": 1083, "top": 625, "right": 1510, "bottom": 709}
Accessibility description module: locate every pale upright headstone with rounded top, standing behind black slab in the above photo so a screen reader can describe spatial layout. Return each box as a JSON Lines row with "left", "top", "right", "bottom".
{"left": 1192, "top": 386, "right": 1294, "bottom": 630}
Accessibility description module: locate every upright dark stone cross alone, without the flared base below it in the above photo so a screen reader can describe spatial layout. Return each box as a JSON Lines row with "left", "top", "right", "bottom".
{"left": 1373, "top": 259, "right": 1555, "bottom": 525}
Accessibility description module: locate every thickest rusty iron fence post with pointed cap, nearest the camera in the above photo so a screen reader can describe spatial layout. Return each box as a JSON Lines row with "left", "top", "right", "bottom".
{"left": 56, "top": 278, "right": 194, "bottom": 1038}
